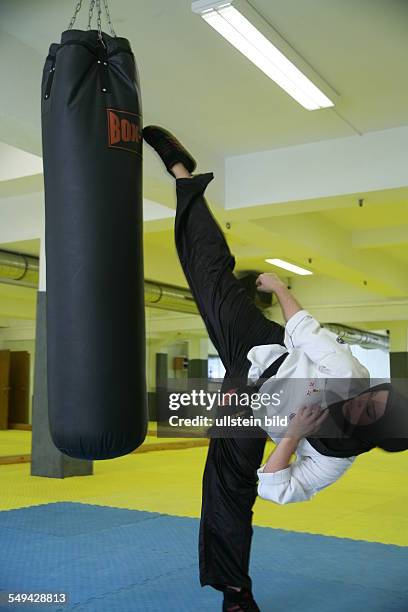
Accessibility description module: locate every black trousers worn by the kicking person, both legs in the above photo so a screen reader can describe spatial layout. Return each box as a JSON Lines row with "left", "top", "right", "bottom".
{"left": 175, "top": 173, "right": 284, "bottom": 590}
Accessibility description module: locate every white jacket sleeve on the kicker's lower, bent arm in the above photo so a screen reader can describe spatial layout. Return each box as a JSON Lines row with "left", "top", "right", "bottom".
{"left": 258, "top": 455, "right": 354, "bottom": 504}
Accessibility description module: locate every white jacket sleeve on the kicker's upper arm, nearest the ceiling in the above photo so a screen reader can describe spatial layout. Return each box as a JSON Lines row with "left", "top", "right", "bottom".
{"left": 285, "top": 310, "right": 370, "bottom": 378}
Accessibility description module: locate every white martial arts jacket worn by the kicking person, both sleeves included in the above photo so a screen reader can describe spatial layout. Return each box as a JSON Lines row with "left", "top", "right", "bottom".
{"left": 247, "top": 310, "right": 370, "bottom": 504}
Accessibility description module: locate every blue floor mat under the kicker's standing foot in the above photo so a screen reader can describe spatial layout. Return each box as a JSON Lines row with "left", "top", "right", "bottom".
{"left": 0, "top": 502, "right": 408, "bottom": 612}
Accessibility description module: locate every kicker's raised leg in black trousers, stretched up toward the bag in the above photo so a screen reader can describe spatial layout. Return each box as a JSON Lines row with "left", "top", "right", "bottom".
{"left": 175, "top": 173, "right": 284, "bottom": 376}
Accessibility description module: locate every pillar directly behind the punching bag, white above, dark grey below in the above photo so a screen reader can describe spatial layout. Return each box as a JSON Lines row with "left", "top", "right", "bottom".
{"left": 31, "top": 234, "right": 93, "bottom": 478}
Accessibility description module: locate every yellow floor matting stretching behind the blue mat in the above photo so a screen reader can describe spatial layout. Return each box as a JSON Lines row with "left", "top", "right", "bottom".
{"left": 0, "top": 432, "right": 408, "bottom": 546}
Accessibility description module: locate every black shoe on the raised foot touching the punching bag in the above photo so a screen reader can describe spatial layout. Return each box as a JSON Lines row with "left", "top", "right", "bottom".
{"left": 143, "top": 125, "right": 197, "bottom": 176}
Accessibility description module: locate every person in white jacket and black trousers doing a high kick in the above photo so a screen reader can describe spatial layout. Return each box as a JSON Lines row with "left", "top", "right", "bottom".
{"left": 143, "top": 126, "right": 406, "bottom": 612}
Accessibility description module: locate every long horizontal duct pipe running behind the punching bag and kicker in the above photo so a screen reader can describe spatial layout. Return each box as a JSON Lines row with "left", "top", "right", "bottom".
{"left": 0, "top": 250, "right": 389, "bottom": 350}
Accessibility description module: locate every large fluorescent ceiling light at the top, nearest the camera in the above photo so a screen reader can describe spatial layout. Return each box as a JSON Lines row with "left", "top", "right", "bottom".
{"left": 193, "top": 1, "right": 334, "bottom": 110}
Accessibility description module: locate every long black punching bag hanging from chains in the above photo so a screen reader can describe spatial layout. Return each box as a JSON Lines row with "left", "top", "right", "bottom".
{"left": 41, "top": 30, "right": 147, "bottom": 459}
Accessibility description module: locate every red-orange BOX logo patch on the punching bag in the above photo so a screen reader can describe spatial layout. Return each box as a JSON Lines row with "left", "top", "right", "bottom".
{"left": 106, "top": 108, "right": 142, "bottom": 155}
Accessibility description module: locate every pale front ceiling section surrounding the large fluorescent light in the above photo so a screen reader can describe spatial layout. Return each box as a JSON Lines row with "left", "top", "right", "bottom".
{"left": 0, "top": 0, "right": 408, "bottom": 156}
